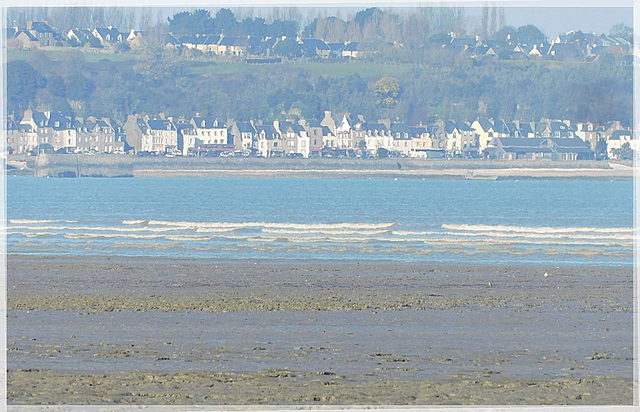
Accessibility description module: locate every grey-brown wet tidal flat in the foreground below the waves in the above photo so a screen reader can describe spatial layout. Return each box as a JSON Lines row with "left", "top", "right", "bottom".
{"left": 7, "top": 256, "right": 633, "bottom": 405}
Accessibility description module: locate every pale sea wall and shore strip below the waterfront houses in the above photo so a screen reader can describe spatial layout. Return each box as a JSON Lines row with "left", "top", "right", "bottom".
{"left": 8, "top": 154, "right": 633, "bottom": 179}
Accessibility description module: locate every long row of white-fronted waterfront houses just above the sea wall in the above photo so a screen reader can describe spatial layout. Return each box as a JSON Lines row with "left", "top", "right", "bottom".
{"left": 6, "top": 110, "right": 638, "bottom": 160}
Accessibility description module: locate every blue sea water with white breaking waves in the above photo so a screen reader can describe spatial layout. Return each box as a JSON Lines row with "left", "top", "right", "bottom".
{"left": 7, "top": 177, "right": 635, "bottom": 266}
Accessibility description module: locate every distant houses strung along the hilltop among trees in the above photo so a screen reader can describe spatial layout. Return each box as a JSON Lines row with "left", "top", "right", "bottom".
{"left": 7, "top": 21, "right": 632, "bottom": 64}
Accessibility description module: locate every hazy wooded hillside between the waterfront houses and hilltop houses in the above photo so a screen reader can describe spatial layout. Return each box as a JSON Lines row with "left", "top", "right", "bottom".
{"left": 7, "top": 49, "right": 633, "bottom": 124}
